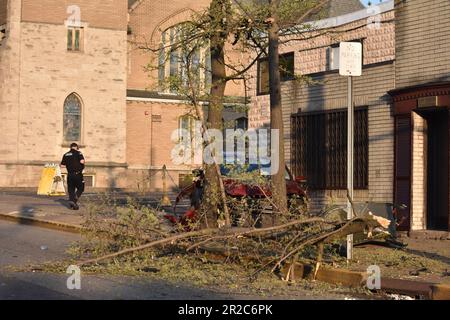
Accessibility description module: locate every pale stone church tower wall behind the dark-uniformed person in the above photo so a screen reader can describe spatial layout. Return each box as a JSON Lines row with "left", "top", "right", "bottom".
{"left": 0, "top": 0, "right": 127, "bottom": 187}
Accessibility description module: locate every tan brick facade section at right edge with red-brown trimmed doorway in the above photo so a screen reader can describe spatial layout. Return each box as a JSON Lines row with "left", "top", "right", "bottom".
{"left": 390, "top": 0, "right": 450, "bottom": 230}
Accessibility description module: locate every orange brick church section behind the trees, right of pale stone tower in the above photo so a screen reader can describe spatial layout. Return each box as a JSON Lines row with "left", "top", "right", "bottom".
{"left": 127, "top": 0, "right": 247, "bottom": 189}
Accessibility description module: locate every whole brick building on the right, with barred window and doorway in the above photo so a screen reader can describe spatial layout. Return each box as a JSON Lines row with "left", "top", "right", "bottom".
{"left": 249, "top": 0, "right": 450, "bottom": 230}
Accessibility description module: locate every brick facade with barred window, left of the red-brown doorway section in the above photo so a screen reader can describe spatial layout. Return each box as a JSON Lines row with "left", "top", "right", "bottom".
{"left": 249, "top": 1, "right": 395, "bottom": 211}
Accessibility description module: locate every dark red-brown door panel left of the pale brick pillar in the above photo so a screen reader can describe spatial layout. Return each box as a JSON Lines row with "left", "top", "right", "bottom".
{"left": 394, "top": 115, "right": 411, "bottom": 231}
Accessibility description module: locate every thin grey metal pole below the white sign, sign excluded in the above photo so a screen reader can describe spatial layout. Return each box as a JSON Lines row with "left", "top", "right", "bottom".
{"left": 347, "top": 76, "right": 355, "bottom": 260}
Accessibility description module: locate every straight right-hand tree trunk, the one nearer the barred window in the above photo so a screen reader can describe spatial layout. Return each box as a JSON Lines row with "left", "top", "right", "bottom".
{"left": 269, "top": 0, "right": 287, "bottom": 213}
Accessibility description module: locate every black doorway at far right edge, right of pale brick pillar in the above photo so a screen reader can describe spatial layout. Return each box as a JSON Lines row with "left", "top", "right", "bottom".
{"left": 426, "top": 109, "right": 449, "bottom": 231}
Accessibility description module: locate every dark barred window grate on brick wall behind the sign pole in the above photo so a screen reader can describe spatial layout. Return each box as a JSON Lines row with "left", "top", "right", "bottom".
{"left": 292, "top": 108, "right": 369, "bottom": 190}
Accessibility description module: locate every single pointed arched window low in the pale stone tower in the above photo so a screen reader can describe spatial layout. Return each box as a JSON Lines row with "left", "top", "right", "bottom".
{"left": 63, "top": 93, "right": 81, "bottom": 142}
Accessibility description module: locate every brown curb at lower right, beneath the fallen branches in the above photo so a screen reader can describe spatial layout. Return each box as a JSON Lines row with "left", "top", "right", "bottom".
{"left": 281, "top": 263, "right": 450, "bottom": 300}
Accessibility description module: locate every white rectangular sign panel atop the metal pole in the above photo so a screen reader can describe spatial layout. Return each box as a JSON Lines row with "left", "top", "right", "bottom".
{"left": 339, "top": 42, "right": 362, "bottom": 77}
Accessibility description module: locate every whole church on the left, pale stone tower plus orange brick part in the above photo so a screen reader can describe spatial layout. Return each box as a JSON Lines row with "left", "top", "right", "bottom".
{"left": 0, "top": 0, "right": 246, "bottom": 190}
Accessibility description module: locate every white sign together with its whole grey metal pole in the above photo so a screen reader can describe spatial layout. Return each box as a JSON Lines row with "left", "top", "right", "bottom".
{"left": 339, "top": 42, "right": 362, "bottom": 260}
